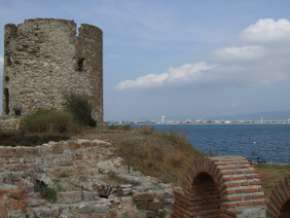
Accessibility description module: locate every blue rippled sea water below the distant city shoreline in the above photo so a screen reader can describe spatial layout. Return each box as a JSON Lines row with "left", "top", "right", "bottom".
{"left": 154, "top": 125, "right": 290, "bottom": 163}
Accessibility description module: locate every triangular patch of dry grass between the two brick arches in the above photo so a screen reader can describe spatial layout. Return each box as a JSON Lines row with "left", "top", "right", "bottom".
{"left": 255, "top": 164, "right": 290, "bottom": 196}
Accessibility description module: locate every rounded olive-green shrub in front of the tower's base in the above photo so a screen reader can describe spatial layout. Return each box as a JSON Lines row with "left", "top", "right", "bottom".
{"left": 20, "top": 109, "right": 76, "bottom": 134}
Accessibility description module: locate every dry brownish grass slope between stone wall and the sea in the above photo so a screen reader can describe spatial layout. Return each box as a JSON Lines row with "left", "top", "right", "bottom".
{"left": 81, "top": 127, "right": 203, "bottom": 183}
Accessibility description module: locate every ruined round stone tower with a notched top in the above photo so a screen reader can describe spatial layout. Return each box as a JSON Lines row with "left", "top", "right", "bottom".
{"left": 3, "top": 19, "right": 103, "bottom": 122}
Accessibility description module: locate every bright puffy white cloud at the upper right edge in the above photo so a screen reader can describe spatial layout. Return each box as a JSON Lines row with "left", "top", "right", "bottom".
{"left": 242, "top": 19, "right": 290, "bottom": 43}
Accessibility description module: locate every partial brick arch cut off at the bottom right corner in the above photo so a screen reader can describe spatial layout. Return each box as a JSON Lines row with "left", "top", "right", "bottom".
{"left": 267, "top": 175, "right": 290, "bottom": 218}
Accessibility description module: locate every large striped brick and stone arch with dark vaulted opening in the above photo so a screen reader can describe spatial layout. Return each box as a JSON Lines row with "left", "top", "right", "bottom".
{"left": 172, "top": 156, "right": 265, "bottom": 218}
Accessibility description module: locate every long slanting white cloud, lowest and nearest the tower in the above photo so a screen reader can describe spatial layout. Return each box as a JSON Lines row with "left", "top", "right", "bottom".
{"left": 116, "top": 62, "right": 213, "bottom": 90}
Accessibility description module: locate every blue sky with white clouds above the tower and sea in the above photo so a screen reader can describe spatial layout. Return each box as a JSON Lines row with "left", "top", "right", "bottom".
{"left": 0, "top": 0, "right": 290, "bottom": 120}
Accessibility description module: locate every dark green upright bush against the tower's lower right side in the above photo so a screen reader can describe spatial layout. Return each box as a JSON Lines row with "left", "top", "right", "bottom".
{"left": 65, "top": 94, "right": 97, "bottom": 126}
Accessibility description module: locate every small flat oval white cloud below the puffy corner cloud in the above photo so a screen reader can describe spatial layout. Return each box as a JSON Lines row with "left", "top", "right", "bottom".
{"left": 214, "top": 46, "right": 266, "bottom": 61}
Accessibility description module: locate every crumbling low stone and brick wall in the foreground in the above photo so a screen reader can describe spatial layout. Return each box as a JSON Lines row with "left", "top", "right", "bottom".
{"left": 0, "top": 139, "right": 173, "bottom": 218}
